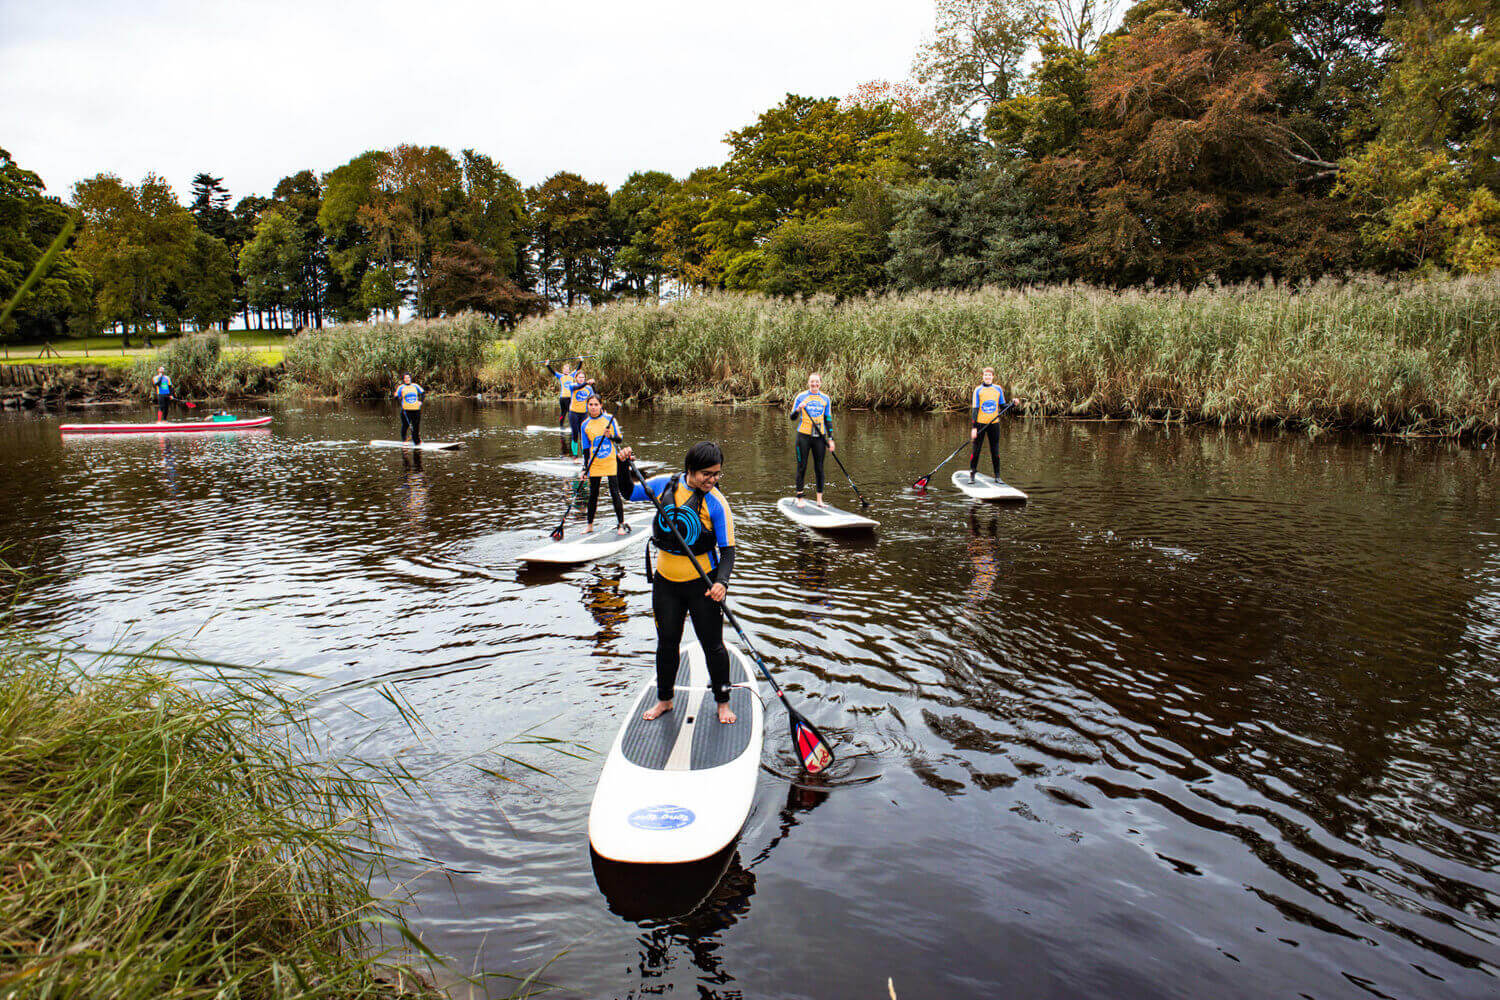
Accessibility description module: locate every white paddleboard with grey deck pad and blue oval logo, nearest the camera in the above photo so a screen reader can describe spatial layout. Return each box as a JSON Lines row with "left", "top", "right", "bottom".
{"left": 588, "top": 642, "right": 765, "bottom": 865}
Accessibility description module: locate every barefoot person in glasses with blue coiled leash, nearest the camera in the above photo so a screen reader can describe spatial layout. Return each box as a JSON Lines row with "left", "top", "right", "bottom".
{"left": 620, "top": 441, "right": 735, "bottom": 723}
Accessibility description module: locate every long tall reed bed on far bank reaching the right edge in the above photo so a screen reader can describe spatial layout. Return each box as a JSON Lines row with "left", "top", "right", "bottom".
{"left": 491, "top": 277, "right": 1500, "bottom": 435}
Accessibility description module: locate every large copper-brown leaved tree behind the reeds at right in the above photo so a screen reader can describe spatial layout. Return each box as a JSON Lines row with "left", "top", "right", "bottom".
{"left": 1032, "top": 15, "right": 1358, "bottom": 285}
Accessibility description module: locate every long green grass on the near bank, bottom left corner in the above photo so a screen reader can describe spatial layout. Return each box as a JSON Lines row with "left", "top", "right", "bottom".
{"left": 0, "top": 637, "right": 435, "bottom": 1000}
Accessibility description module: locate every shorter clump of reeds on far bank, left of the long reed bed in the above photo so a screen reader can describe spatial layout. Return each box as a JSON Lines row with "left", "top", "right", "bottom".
{"left": 285, "top": 313, "right": 503, "bottom": 399}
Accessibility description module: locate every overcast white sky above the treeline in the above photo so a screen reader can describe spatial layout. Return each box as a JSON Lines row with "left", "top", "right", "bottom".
{"left": 0, "top": 0, "right": 933, "bottom": 199}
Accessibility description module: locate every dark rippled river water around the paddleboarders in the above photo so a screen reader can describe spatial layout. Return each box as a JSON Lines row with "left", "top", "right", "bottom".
{"left": 0, "top": 403, "right": 1500, "bottom": 1000}
